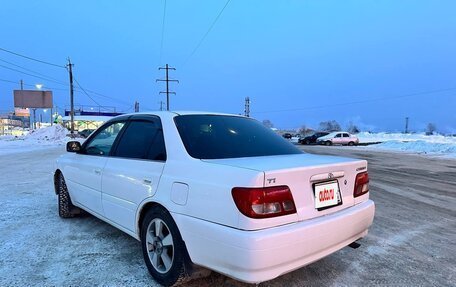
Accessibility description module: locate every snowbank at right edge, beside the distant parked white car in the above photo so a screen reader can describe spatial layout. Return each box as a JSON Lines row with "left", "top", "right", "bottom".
{"left": 357, "top": 132, "right": 456, "bottom": 158}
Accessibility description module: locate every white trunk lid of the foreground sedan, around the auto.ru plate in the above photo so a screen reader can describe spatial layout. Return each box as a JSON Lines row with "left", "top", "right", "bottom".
{"left": 206, "top": 154, "right": 367, "bottom": 221}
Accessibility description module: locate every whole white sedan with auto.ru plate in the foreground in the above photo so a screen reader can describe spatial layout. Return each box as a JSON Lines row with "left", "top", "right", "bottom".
{"left": 54, "top": 112, "right": 375, "bottom": 286}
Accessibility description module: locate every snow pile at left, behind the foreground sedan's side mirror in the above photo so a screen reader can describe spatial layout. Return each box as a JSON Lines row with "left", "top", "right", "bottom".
{"left": 0, "top": 125, "right": 70, "bottom": 155}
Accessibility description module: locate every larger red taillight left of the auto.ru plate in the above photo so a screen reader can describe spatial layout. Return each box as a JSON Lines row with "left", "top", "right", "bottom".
{"left": 231, "top": 185, "right": 296, "bottom": 218}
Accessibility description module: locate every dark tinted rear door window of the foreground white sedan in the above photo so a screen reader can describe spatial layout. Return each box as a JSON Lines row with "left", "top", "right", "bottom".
{"left": 113, "top": 119, "right": 166, "bottom": 161}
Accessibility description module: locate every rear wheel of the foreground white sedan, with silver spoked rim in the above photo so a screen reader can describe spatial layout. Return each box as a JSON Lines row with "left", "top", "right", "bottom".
{"left": 140, "top": 207, "right": 190, "bottom": 286}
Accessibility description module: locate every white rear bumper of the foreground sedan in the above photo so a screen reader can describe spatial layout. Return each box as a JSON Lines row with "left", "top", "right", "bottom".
{"left": 172, "top": 200, "right": 375, "bottom": 283}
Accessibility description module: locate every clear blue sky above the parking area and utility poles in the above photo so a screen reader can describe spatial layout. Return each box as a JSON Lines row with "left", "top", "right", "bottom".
{"left": 0, "top": 0, "right": 456, "bottom": 133}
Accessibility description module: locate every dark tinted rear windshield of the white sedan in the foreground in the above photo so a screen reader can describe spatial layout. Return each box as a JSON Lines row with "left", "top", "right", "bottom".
{"left": 174, "top": 115, "right": 302, "bottom": 159}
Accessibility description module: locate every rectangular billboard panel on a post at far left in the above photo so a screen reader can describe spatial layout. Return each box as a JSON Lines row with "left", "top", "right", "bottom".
{"left": 14, "top": 90, "right": 53, "bottom": 109}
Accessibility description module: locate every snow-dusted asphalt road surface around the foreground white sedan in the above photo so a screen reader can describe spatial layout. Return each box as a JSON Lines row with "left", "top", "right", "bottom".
{"left": 0, "top": 146, "right": 456, "bottom": 287}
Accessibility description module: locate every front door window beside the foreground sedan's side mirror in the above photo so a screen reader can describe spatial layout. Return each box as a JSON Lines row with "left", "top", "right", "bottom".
{"left": 84, "top": 122, "right": 125, "bottom": 156}
